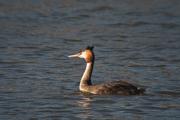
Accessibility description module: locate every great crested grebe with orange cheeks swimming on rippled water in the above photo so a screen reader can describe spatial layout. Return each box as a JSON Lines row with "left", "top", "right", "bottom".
{"left": 68, "top": 46, "right": 145, "bottom": 95}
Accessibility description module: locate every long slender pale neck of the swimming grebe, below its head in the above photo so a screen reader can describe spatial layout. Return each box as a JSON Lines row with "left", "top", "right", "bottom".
{"left": 79, "top": 62, "right": 94, "bottom": 88}
